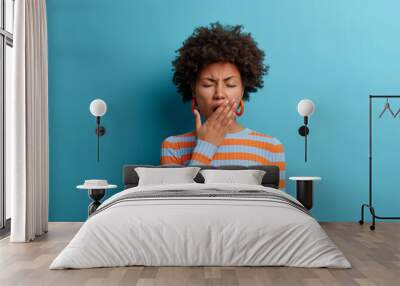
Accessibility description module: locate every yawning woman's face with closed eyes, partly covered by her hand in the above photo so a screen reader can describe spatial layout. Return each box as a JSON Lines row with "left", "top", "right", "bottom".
{"left": 193, "top": 62, "right": 244, "bottom": 118}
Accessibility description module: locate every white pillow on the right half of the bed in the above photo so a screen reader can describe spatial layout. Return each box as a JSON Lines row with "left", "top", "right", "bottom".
{"left": 200, "top": 169, "right": 266, "bottom": 185}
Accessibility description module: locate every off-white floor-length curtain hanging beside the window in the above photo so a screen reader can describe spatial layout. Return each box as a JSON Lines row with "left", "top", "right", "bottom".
{"left": 6, "top": 0, "right": 49, "bottom": 242}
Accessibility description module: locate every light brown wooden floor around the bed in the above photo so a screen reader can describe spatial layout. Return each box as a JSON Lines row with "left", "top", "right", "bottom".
{"left": 0, "top": 222, "right": 400, "bottom": 286}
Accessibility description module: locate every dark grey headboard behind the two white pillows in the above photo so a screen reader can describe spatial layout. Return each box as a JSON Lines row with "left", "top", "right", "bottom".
{"left": 122, "top": 165, "right": 279, "bottom": 189}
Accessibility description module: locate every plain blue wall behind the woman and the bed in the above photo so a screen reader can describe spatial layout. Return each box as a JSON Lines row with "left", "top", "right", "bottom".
{"left": 47, "top": 0, "right": 400, "bottom": 221}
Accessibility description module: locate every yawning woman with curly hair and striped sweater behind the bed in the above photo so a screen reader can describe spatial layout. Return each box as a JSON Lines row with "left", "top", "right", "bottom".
{"left": 161, "top": 23, "right": 285, "bottom": 189}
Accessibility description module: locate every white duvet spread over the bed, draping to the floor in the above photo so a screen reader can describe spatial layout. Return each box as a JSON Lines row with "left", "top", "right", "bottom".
{"left": 50, "top": 183, "right": 351, "bottom": 269}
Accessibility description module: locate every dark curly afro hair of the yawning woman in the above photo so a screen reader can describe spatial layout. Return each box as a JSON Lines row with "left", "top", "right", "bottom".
{"left": 172, "top": 22, "right": 269, "bottom": 102}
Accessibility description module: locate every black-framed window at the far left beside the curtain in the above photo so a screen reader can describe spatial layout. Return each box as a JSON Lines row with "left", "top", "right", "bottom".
{"left": 0, "top": 0, "right": 14, "bottom": 233}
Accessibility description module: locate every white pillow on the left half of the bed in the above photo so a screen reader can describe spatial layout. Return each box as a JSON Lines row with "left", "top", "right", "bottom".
{"left": 135, "top": 167, "right": 200, "bottom": 186}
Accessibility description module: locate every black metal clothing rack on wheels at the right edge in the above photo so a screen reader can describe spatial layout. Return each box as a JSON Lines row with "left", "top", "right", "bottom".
{"left": 359, "top": 95, "right": 400, "bottom": 230}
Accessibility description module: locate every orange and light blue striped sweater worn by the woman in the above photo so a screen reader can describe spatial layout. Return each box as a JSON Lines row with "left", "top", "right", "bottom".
{"left": 160, "top": 128, "right": 286, "bottom": 190}
